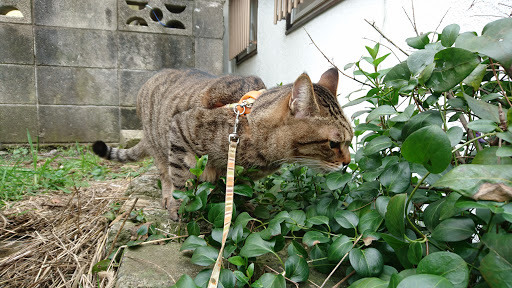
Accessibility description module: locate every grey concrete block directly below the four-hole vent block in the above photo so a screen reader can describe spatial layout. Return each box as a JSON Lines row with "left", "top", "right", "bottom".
{"left": 118, "top": 32, "right": 194, "bottom": 70}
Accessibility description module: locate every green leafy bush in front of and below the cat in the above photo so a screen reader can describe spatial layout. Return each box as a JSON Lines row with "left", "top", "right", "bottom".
{"left": 176, "top": 18, "right": 512, "bottom": 288}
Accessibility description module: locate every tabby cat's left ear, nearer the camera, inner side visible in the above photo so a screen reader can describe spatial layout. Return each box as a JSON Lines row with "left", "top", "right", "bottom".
{"left": 289, "top": 73, "right": 318, "bottom": 118}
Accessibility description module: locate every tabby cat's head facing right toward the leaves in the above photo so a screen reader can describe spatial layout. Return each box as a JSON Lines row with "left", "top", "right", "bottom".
{"left": 249, "top": 68, "right": 354, "bottom": 171}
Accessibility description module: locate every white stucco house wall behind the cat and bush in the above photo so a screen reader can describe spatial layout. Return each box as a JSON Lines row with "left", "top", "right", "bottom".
{"left": 225, "top": 0, "right": 512, "bottom": 116}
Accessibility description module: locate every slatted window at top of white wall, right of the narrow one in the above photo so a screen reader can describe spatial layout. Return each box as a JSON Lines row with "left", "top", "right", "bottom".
{"left": 274, "top": 0, "right": 342, "bottom": 34}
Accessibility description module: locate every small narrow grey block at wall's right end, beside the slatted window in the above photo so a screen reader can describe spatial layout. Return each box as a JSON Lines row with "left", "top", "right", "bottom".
{"left": 196, "top": 38, "right": 224, "bottom": 75}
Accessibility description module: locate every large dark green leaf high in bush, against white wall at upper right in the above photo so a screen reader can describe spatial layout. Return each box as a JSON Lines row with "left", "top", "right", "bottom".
{"left": 425, "top": 48, "right": 480, "bottom": 92}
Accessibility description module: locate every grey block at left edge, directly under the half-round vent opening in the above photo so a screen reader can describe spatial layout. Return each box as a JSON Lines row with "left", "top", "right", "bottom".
{"left": 0, "top": 24, "right": 34, "bottom": 64}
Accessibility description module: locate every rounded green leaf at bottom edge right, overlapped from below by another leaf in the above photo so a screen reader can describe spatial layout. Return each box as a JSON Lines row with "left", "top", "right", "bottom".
{"left": 416, "top": 251, "right": 469, "bottom": 288}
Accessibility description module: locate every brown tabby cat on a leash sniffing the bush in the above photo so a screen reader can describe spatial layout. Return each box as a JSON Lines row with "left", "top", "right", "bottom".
{"left": 93, "top": 68, "right": 353, "bottom": 220}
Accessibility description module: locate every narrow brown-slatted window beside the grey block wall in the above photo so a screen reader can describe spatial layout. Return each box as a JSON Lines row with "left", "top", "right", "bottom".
{"left": 229, "top": 0, "right": 258, "bottom": 64}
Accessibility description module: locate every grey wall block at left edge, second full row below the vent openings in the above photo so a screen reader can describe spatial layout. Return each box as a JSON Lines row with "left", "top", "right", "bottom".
{"left": 0, "top": 65, "right": 36, "bottom": 104}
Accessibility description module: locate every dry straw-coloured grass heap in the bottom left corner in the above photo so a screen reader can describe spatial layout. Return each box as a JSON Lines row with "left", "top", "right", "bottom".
{"left": 0, "top": 179, "right": 129, "bottom": 288}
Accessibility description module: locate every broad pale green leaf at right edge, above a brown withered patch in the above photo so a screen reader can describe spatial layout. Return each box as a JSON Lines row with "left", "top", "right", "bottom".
{"left": 434, "top": 164, "right": 512, "bottom": 197}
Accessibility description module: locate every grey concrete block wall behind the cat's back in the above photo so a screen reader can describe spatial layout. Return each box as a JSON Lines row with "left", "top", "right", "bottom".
{"left": 0, "top": 0, "right": 224, "bottom": 144}
